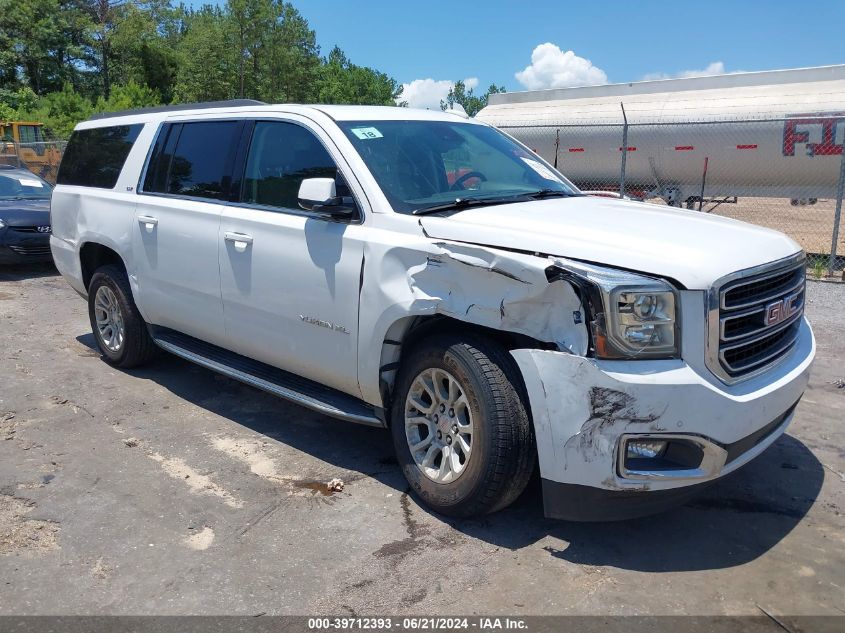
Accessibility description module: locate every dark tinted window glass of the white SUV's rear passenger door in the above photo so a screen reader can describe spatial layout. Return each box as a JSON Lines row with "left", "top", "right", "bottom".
{"left": 162, "top": 121, "right": 241, "bottom": 200}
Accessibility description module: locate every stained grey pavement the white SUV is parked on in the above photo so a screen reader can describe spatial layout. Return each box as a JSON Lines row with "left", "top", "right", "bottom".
{"left": 0, "top": 268, "right": 845, "bottom": 615}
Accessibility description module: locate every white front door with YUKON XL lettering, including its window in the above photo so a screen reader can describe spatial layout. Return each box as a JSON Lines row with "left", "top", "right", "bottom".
{"left": 219, "top": 115, "right": 364, "bottom": 395}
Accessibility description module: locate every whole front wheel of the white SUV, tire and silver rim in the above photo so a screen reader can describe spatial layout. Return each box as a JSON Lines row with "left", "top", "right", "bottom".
{"left": 391, "top": 333, "right": 536, "bottom": 517}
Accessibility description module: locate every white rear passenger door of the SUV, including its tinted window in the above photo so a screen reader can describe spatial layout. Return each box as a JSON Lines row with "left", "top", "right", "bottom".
{"left": 132, "top": 120, "right": 243, "bottom": 345}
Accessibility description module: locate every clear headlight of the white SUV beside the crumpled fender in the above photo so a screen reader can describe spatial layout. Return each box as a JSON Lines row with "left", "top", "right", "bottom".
{"left": 549, "top": 260, "right": 680, "bottom": 359}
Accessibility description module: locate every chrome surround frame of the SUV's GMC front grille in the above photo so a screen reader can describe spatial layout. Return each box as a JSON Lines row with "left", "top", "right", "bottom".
{"left": 704, "top": 251, "right": 807, "bottom": 385}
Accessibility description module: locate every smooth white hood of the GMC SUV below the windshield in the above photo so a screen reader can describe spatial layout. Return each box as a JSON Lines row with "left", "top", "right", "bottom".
{"left": 420, "top": 196, "right": 801, "bottom": 290}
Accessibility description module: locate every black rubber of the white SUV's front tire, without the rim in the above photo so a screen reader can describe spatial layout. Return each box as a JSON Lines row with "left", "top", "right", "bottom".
{"left": 391, "top": 332, "right": 537, "bottom": 517}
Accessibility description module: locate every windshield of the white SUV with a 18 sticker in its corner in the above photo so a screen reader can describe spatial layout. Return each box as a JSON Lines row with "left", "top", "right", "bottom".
{"left": 338, "top": 121, "right": 578, "bottom": 213}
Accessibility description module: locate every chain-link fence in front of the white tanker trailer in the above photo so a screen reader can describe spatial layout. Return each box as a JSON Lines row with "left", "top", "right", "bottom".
{"left": 502, "top": 113, "right": 845, "bottom": 277}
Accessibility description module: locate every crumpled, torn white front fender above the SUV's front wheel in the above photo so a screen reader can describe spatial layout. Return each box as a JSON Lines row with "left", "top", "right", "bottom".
{"left": 359, "top": 233, "right": 589, "bottom": 403}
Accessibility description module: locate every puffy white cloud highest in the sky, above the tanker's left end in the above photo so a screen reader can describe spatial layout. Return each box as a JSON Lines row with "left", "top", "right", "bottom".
{"left": 514, "top": 42, "right": 607, "bottom": 90}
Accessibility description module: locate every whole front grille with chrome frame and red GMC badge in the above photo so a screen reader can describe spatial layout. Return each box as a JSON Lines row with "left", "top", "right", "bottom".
{"left": 707, "top": 253, "right": 806, "bottom": 382}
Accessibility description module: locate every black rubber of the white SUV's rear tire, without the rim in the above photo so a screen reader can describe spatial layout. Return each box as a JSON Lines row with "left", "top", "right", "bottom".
{"left": 88, "top": 265, "right": 158, "bottom": 369}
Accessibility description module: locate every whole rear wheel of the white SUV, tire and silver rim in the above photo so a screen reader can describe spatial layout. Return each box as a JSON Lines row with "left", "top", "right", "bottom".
{"left": 88, "top": 265, "right": 157, "bottom": 368}
